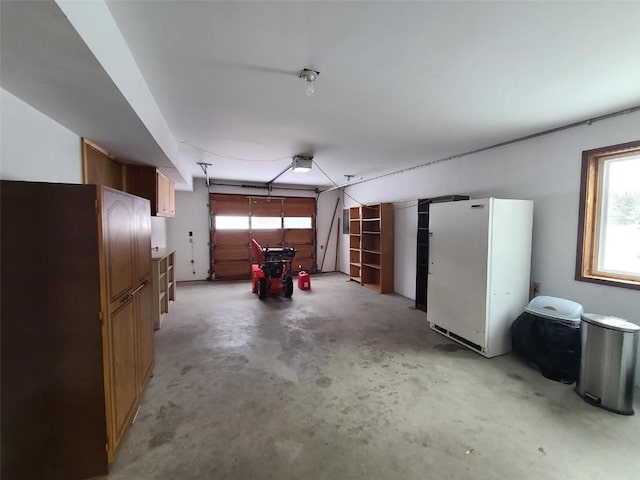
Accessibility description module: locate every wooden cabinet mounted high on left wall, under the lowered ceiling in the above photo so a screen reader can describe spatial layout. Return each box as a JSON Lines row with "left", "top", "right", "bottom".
{"left": 124, "top": 165, "right": 176, "bottom": 217}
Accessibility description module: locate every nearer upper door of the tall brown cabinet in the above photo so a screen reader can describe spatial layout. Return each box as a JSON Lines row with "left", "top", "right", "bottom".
{"left": 102, "top": 188, "right": 135, "bottom": 312}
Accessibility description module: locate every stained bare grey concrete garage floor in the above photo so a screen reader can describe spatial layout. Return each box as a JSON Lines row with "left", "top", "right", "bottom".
{"left": 109, "top": 274, "right": 640, "bottom": 480}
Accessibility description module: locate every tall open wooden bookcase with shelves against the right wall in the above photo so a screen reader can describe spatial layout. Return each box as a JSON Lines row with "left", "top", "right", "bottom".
{"left": 349, "top": 203, "right": 394, "bottom": 293}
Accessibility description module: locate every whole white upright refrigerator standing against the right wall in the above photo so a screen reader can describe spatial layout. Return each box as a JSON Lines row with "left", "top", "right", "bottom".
{"left": 427, "top": 198, "right": 533, "bottom": 357}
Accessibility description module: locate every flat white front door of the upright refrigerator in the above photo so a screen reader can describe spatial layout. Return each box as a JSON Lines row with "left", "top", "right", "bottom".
{"left": 427, "top": 199, "right": 490, "bottom": 346}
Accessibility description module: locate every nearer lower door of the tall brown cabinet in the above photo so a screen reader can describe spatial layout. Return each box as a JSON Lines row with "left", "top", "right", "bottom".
{"left": 109, "top": 300, "right": 139, "bottom": 458}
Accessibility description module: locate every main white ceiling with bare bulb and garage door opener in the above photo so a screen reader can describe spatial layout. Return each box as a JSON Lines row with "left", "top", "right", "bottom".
{"left": 2, "top": 0, "right": 640, "bottom": 189}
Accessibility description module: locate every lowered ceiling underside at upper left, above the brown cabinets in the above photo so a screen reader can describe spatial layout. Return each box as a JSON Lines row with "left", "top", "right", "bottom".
{"left": 0, "top": 1, "right": 172, "bottom": 177}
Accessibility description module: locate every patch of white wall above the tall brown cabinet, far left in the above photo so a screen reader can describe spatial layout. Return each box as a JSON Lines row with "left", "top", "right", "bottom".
{"left": 0, "top": 89, "right": 82, "bottom": 183}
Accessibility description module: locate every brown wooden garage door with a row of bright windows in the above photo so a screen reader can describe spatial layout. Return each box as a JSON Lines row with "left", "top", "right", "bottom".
{"left": 209, "top": 193, "right": 316, "bottom": 280}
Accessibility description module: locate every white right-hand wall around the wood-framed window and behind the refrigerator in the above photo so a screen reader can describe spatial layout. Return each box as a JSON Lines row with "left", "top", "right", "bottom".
{"left": 341, "top": 112, "right": 640, "bottom": 384}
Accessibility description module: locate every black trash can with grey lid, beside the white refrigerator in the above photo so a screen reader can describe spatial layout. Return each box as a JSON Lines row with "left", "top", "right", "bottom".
{"left": 511, "top": 296, "right": 583, "bottom": 384}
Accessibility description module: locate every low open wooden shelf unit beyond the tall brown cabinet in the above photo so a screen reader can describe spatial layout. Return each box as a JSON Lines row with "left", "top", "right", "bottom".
{"left": 151, "top": 248, "right": 176, "bottom": 330}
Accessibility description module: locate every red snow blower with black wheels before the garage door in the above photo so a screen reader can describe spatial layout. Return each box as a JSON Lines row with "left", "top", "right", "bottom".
{"left": 251, "top": 238, "right": 296, "bottom": 300}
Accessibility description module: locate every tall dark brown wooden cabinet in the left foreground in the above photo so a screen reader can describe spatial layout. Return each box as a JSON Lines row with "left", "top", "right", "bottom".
{"left": 0, "top": 181, "right": 154, "bottom": 480}
